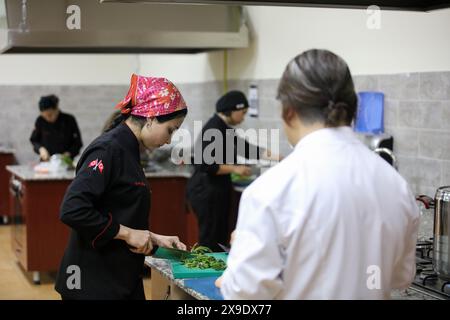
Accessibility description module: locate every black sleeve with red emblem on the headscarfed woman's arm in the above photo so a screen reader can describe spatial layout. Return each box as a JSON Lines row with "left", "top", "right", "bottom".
{"left": 60, "top": 146, "right": 120, "bottom": 248}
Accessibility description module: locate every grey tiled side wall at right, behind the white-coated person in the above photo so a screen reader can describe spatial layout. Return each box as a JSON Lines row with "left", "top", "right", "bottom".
{"left": 230, "top": 72, "right": 450, "bottom": 196}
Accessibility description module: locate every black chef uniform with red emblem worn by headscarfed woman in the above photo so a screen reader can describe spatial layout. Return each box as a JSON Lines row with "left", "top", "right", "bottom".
{"left": 56, "top": 123, "right": 150, "bottom": 299}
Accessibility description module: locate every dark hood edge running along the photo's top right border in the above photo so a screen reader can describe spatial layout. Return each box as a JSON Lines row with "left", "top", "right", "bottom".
{"left": 100, "top": 0, "right": 450, "bottom": 11}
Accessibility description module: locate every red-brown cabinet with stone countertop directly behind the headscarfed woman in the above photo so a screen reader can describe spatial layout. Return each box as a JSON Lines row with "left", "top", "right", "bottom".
{"left": 7, "top": 166, "right": 198, "bottom": 283}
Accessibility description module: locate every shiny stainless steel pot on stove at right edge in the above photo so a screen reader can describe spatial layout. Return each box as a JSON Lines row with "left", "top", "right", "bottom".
{"left": 433, "top": 186, "right": 450, "bottom": 281}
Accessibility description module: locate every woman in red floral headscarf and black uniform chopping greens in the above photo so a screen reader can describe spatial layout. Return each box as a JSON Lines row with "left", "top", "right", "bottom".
{"left": 55, "top": 74, "right": 187, "bottom": 299}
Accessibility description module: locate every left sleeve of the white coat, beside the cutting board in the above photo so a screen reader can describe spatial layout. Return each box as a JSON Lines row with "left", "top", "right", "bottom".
{"left": 221, "top": 190, "right": 283, "bottom": 300}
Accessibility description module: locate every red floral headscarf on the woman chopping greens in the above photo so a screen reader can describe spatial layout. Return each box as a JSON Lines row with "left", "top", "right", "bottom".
{"left": 116, "top": 74, "right": 187, "bottom": 118}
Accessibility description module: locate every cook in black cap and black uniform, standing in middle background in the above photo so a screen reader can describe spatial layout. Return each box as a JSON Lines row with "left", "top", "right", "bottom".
{"left": 186, "top": 91, "right": 278, "bottom": 251}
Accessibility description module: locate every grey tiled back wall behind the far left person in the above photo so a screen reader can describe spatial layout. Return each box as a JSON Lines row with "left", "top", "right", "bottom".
{"left": 0, "top": 82, "right": 222, "bottom": 164}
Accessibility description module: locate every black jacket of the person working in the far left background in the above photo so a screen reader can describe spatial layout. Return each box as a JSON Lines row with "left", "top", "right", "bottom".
{"left": 30, "top": 112, "right": 83, "bottom": 158}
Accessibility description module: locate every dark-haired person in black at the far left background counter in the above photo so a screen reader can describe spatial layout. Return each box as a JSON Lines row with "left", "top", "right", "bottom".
{"left": 30, "top": 95, "right": 83, "bottom": 161}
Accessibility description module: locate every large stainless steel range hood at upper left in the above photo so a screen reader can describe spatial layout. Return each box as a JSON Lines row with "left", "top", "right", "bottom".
{"left": 0, "top": 0, "right": 248, "bottom": 53}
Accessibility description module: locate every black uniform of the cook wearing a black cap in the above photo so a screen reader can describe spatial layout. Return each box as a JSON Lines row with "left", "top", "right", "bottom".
{"left": 187, "top": 114, "right": 260, "bottom": 251}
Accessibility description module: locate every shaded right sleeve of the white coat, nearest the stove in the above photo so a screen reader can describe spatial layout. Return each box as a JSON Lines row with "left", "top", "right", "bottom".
{"left": 392, "top": 190, "right": 419, "bottom": 289}
